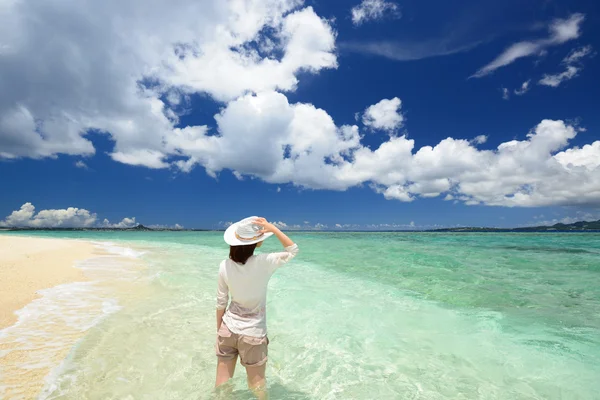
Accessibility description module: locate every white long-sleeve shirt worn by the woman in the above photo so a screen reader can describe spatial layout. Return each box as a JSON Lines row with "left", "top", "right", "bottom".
{"left": 217, "top": 244, "right": 298, "bottom": 337}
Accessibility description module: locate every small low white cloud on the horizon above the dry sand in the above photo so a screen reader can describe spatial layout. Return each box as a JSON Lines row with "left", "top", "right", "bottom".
{"left": 0, "top": 203, "right": 96, "bottom": 228}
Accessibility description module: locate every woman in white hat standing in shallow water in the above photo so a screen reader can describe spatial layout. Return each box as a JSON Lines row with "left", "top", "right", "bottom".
{"left": 216, "top": 217, "right": 298, "bottom": 398}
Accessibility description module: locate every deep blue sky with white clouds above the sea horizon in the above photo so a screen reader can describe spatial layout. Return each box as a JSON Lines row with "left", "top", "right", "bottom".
{"left": 0, "top": 0, "right": 600, "bottom": 229}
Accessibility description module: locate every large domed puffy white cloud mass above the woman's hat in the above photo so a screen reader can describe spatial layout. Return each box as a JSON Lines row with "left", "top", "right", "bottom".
{"left": 171, "top": 92, "right": 360, "bottom": 189}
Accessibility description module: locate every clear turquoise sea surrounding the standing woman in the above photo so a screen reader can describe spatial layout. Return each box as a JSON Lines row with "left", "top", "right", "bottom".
{"left": 1, "top": 232, "right": 600, "bottom": 400}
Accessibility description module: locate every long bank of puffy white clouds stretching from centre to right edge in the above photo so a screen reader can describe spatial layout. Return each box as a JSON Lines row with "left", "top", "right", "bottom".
{"left": 171, "top": 98, "right": 600, "bottom": 207}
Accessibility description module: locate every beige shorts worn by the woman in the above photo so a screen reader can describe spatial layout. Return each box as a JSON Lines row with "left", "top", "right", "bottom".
{"left": 216, "top": 322, "right": 269, "bottom": 367}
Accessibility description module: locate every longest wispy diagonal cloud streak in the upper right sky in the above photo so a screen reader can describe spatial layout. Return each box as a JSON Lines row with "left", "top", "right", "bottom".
{"left": 472, "top": 13, "right": 585, "bottom": 78}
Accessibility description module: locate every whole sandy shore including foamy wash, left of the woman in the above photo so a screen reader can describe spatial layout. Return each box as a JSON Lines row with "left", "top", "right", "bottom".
{"left": 0, "top": 234, "right": 145, "bottom": 400}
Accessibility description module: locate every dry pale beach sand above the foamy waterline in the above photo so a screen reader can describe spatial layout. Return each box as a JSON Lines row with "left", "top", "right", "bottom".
{"left": 0, "top": 235, "right": 94, "bottom": 329}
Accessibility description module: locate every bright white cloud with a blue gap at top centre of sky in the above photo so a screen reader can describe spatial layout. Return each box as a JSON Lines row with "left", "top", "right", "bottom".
{"left": 159, "top": 6, "right": 337, "bottom": 101}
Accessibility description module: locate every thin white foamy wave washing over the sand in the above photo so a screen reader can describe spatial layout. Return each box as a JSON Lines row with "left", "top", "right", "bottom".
{"left": 0, "top": 242, "right": 145, "bottom": 398}
